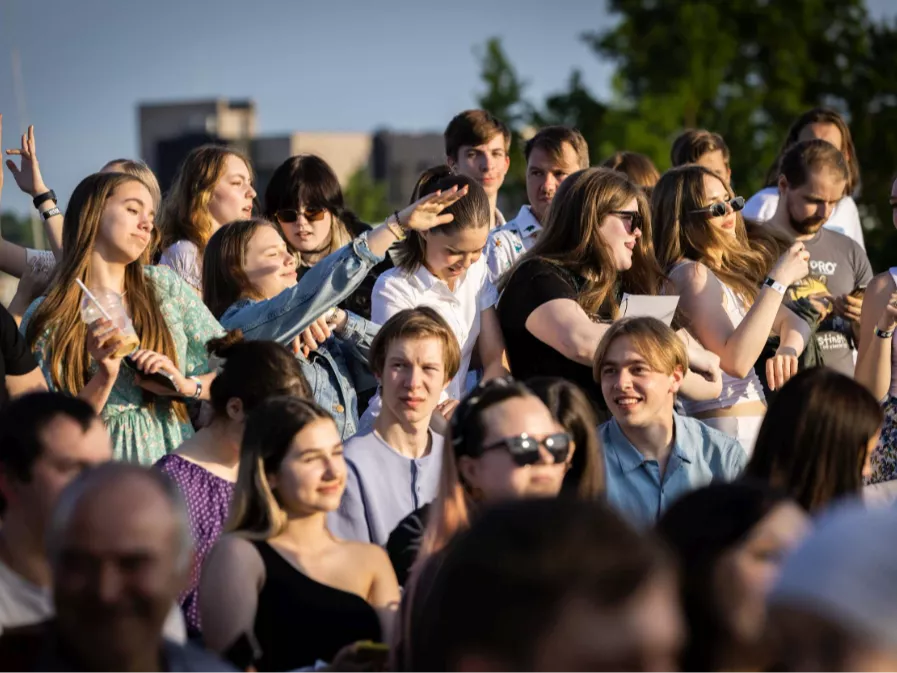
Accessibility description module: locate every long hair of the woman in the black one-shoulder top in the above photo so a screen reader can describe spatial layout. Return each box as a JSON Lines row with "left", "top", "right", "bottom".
{"left": 225, "top": 397, "right": 333, "bottom": 540}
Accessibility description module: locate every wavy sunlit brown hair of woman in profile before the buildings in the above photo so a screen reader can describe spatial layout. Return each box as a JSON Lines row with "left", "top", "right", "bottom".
{"left": 158, "top": 145, "right": 254, "bottom": 254}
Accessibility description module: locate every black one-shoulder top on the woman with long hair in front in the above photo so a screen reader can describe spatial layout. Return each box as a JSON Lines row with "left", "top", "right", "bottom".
{"left": 252, "top": 541, "right": 381, "bottom": 673}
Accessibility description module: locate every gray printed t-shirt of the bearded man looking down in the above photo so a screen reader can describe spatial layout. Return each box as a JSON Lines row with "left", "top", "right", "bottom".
{"left": 789, "top": 229, "right": 872, "bottom": 377}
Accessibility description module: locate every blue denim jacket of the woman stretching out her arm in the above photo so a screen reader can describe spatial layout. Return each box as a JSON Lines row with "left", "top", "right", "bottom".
{"left": 220, "top": 234, "right": 383, "bottom": 439}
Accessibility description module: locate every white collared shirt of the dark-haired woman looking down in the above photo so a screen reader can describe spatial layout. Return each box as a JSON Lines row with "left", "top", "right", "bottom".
{"left": 371, "top": 257, "right": 498, "bottom": 400}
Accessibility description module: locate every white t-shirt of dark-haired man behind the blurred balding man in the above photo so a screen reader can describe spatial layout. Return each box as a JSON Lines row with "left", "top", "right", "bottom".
{"left": 0, "top": 561, "right": 187, "bottom": 645}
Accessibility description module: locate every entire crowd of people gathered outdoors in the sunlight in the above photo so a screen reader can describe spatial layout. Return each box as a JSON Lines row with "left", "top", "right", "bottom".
{"left": 0, "top": 102, "right": 897, "bottom": 673}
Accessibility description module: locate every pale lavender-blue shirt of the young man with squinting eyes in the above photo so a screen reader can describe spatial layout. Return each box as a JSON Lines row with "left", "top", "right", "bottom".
{"left": 327, "top": 431, "right": 444, "bottom": 546}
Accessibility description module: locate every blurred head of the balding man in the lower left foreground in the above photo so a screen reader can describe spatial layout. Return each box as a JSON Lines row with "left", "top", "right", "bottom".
{"left": 54, "top": 475, "right": 189, "bottom": 670}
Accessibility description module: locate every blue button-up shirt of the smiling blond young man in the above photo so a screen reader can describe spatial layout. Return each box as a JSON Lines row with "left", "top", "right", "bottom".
{"left": 598, "top": 413, "right": 747, "bottom": 526}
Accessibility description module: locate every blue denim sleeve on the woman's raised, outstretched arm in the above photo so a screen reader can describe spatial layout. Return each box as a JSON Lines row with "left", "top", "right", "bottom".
{"left": 221, "top": 233, "right": 383, "bottom": 343}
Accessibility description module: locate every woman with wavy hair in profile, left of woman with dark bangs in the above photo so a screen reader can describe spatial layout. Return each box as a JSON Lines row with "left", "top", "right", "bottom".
{"left": 159, "top": 145, "right": 256, "bottom": 292}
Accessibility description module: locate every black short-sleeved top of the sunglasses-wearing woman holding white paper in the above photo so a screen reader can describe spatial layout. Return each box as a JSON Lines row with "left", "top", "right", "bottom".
{"left": 498, "top": 259, "right": 607, "bottom": 412}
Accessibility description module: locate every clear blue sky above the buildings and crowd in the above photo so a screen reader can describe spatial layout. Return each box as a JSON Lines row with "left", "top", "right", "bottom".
{"left": 0, "top": 0, "right": 895, "bottom": 212}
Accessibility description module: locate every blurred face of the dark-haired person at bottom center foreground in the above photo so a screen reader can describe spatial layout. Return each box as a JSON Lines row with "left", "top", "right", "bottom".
{"left": 531, "top": 574, "right": 684, "bottom": 673}
